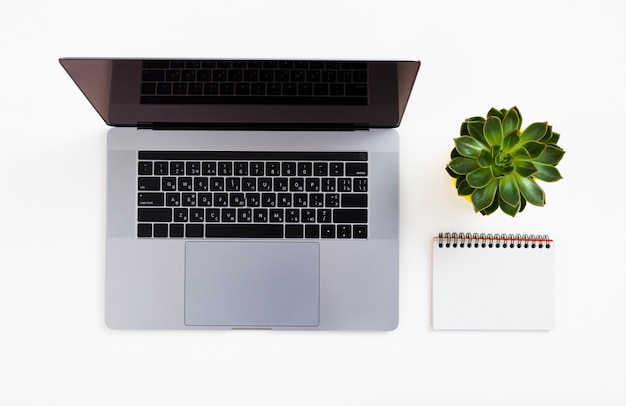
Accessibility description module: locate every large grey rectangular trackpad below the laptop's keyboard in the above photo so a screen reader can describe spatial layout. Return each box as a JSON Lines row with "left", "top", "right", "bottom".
{"left": 180, "top": 241, "right": 320, "bottom": 327}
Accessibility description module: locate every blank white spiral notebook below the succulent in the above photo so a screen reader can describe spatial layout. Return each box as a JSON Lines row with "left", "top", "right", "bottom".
{"left": 432, "top": 233, "right": 555, "bottom": 330}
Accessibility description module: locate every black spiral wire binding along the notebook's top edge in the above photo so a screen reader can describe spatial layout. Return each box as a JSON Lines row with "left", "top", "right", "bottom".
{"left": 438, "top": 233, "right": 552, "bottom": 249}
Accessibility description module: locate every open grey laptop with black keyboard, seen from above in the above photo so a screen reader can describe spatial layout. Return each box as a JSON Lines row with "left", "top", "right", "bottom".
{"left": 60, "top": 58, "right": 420, "bottom": 330}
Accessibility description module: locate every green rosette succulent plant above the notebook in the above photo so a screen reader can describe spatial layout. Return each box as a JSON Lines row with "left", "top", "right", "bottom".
{"left": 446, "top": 107, "right": 565, "bottom": 216}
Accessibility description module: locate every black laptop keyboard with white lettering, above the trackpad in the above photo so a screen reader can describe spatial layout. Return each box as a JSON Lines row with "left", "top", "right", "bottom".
{"left": 137, "top": 151, "right": 368, "bottom": 239}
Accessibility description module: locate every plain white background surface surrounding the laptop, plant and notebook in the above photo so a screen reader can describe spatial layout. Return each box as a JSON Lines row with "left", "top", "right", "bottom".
{"left": 0, "top": 0, "right": 626, "bottom": 405}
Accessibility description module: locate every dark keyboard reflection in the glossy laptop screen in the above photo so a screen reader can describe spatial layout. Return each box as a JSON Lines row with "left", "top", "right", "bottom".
{"left": 141, "top": 60, "right": 368, "bottom": 105}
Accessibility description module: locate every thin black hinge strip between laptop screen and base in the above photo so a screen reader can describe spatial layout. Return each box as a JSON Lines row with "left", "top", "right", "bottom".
{"left": 137, "top": 123, "right": 370, "bottom": 131}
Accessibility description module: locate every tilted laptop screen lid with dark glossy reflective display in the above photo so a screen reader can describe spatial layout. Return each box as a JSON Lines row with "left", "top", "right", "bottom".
{"left": 60, "top": 58, "right": 420, "bottom": 129}
